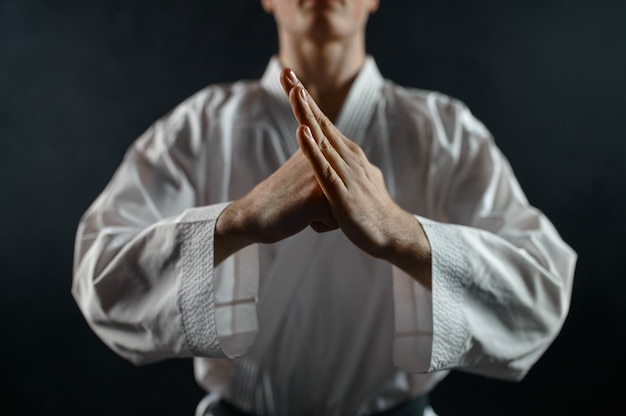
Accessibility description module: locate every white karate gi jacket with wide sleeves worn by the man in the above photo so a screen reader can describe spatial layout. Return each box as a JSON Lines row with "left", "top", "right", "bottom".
{"left": 73, "top": 57, "right": 576, "bottom": 415}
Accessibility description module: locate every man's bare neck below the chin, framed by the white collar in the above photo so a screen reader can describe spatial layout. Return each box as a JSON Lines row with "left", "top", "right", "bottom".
{"left": 278, "top": 36, "right": 366, "bottom": 121}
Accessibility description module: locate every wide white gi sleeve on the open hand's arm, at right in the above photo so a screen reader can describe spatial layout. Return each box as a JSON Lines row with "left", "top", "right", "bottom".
{"left": 394, "top": 96, "right": 576, "bottom": 380}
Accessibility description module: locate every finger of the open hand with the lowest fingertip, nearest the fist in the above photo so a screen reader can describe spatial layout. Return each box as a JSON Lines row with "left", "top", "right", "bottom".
{"left": 296, "top": 125, "right": 346, "bottom": 198}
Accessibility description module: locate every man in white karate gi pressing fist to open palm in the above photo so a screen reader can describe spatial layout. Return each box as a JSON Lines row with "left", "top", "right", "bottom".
{"left": 73, "top": 0, "right": 576, "bottom": 415}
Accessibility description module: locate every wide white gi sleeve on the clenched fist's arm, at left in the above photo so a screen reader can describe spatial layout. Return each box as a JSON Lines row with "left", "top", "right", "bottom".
{"left": 72, "top": 113, "right": 258, "bottom": 364}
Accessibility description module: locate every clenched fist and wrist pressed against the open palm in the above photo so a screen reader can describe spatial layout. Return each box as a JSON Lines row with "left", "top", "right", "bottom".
{"left": 213, "top": 150, "right": 337, "bottom": 265}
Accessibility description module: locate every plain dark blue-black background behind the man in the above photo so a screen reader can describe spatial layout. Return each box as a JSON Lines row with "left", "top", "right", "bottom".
{"left": 0, "top": 0, "right": 626, "bottom": 415}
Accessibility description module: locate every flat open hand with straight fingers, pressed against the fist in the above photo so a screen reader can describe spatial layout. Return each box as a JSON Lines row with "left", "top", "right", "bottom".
{"left": 280, "top": 69, "right": 431, "bottom": 289}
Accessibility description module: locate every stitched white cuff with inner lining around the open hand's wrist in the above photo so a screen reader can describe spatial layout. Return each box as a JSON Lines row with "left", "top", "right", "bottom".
{"left": 393, "top": 217, "right": 469, "bottom": 373}
